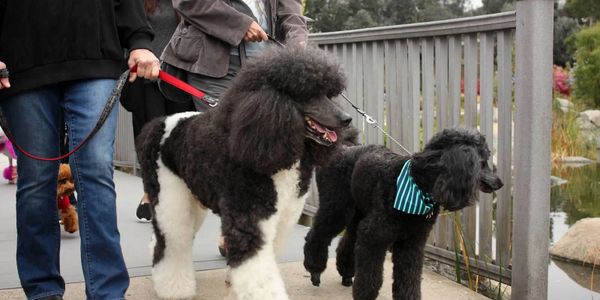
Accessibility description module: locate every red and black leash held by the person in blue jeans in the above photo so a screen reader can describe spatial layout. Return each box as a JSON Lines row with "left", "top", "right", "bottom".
{"left": 0, "top": 66, "right": 214, "bottom": 161}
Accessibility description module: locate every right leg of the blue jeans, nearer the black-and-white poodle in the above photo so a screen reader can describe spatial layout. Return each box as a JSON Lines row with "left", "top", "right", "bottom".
{"left": 64, "top": 79, "right": 129, "bottom": 299}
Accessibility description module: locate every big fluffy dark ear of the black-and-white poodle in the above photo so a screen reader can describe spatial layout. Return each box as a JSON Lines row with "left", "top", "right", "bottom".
{"left": 228, "top": 88, "right": 304, "bottom": 174}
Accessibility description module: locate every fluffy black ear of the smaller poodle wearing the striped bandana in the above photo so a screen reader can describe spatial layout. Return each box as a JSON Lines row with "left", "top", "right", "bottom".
{"left": 432, "top": 145, "right": 481, "bottom": 211}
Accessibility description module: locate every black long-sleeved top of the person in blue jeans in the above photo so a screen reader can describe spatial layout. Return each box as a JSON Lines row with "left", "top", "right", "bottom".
{"left": 0, "top": 0, "right": 153, "bottom": 99}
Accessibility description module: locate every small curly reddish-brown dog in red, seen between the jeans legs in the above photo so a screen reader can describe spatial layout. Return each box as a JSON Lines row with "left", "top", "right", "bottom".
{"left": 56, "top": 164, "right": 78, "bottom": 233}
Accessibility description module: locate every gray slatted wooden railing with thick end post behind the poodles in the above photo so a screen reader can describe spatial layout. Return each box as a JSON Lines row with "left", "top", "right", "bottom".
{"left": 115, "top": 0, "right": 552, "bottom": 299}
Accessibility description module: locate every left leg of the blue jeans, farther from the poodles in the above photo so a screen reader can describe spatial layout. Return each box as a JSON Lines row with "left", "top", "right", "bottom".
{"left": 0, "top": 86, "right": 65, "bottom": 299}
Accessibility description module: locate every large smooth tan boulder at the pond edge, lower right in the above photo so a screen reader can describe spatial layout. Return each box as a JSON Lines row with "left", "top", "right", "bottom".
{"left": 550, "top": 218, "right": 600, "bottom": 265}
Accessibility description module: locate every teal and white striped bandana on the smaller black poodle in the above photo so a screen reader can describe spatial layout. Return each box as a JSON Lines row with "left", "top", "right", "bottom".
{"left": 394, "top": 160, "right": 433, "bottom": 215}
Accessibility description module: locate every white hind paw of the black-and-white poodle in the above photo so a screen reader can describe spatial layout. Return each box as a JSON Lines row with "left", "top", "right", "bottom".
{"left": 152, "top": 264, "right": 196, "bottom": 299}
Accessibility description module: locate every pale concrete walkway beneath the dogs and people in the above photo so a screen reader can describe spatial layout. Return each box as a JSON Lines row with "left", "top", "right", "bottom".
{"left": 0, "top": 156, "right": 486, "bottom": 300}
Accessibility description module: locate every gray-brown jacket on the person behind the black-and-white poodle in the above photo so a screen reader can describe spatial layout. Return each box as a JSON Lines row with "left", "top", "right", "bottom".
{"left": 161, "top": 0, "right": 308, "bottom": 78}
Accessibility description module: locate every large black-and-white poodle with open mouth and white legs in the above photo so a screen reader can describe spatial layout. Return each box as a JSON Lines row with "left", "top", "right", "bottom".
{"left": 137, "top": 47, "right": 351, "bottom": 300}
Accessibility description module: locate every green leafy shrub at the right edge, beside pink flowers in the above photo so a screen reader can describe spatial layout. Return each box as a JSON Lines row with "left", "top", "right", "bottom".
{"left": 568, "top": 23, "right": 600, "bottom": 107}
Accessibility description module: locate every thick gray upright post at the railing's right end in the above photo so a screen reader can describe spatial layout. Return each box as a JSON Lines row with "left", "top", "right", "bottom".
{"left": 512, "top": 0, "right": 554, "bottom": 300}
